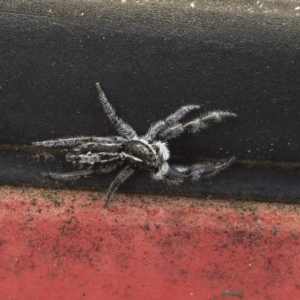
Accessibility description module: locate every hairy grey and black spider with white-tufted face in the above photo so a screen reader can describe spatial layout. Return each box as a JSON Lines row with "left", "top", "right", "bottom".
{"left": 33, "top": 82, "right": 236, "bottom": 208}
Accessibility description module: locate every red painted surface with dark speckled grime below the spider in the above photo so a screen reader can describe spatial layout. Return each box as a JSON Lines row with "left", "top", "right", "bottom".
{"left": 0, "top": 187, "right": 300, "bottom": 300}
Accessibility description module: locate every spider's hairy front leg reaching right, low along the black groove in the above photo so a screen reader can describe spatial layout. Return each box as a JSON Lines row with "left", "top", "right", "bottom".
{"left": 170, "top": 156, "right": 236, "bottom": 180}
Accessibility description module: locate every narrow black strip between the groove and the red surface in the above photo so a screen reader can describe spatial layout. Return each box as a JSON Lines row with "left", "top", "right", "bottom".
{"left": 0, "top": 152, "right": 300, "bottom": 203}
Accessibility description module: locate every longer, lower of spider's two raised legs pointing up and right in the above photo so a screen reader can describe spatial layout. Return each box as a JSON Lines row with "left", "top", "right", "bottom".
{"left": 158, "top": 111, "right": 237, "bottom": 141}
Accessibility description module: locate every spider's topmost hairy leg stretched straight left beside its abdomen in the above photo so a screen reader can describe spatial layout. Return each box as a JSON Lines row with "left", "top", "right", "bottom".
{"left": 32, "top": 136, "right": 126, "bottom": 148}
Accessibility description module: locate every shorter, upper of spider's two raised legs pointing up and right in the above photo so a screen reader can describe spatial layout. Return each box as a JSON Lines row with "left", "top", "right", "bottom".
{"left": 144, "top": 105, "right": 201, "bottom": 141}
